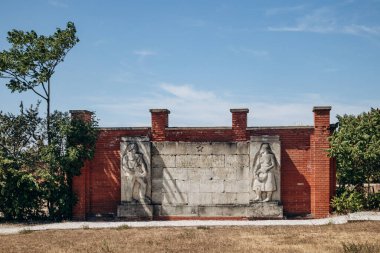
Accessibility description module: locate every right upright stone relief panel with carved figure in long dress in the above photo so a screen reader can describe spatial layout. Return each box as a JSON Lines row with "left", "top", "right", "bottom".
{"left": 250, "top": 136, "right": 281, "bottom": 202}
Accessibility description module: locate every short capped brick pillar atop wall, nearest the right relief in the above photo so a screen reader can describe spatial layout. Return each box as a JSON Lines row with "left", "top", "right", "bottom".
{"left": 230, "top": 108, "right": 249, "bottom": 141}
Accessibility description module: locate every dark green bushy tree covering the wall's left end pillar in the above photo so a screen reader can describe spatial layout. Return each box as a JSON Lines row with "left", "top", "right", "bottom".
{"left": 42, "top": 111, "right": 98, "bottom": 219}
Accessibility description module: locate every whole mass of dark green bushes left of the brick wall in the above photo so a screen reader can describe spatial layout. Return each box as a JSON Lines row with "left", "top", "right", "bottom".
{"left": 0, "top": 106, "right": 97, "bottom": 220}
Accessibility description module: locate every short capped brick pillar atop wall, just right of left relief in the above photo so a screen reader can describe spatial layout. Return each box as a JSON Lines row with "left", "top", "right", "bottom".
{"left": 149, "top": 109, "right": 170, "bottom": 141}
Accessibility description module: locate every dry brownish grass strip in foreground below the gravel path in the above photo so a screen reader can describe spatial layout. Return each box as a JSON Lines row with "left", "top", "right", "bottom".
{"left": 0, "top": 222, "right": 380, "bottom": 253}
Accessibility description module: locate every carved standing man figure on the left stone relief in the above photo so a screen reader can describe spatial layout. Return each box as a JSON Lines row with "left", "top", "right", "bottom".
{"left": 122, "top": 143, "right": 147, "bottom": 202}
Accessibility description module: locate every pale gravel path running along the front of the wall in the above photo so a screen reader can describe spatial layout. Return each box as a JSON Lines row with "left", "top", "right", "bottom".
{"left": 0, "top": 212, "right": 380, "bottom": 234}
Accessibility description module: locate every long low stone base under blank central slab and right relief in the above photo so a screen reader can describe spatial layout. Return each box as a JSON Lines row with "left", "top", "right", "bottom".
{"left": 153, "top": 202, "right": 283, "bottom": 219}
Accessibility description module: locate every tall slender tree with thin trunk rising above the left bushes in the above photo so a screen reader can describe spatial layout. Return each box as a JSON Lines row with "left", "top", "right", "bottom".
{"left": 0, "top": 22, "right": 79, "bottom": 143}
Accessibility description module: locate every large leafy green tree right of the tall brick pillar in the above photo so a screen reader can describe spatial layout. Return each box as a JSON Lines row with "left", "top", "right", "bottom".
{"left": 329, "top": 108, "right": 380, "bottom": 211}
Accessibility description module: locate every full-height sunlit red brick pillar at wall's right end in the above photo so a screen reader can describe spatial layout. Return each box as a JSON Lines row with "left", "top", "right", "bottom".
{"left": 310, "top": 106, "right": 333, "bottom": 218}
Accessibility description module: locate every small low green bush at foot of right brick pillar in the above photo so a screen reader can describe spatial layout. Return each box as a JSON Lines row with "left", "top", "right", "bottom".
{"left": 331, "top": 190, "right": 364, "bottom": 214}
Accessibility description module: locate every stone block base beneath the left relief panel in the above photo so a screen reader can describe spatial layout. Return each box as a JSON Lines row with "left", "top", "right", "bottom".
{"left": 117, "top": 202, "right": 153, "bottom": 220}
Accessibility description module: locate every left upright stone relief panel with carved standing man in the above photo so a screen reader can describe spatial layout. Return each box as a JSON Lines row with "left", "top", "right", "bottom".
{"left": 120, "top": 137, "right": 152, "bottom": 204}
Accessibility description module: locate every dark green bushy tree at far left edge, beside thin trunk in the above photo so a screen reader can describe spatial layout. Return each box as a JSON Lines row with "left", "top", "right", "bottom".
{"left": 0, "top": 105, "right": 43, "bottom": 220}
